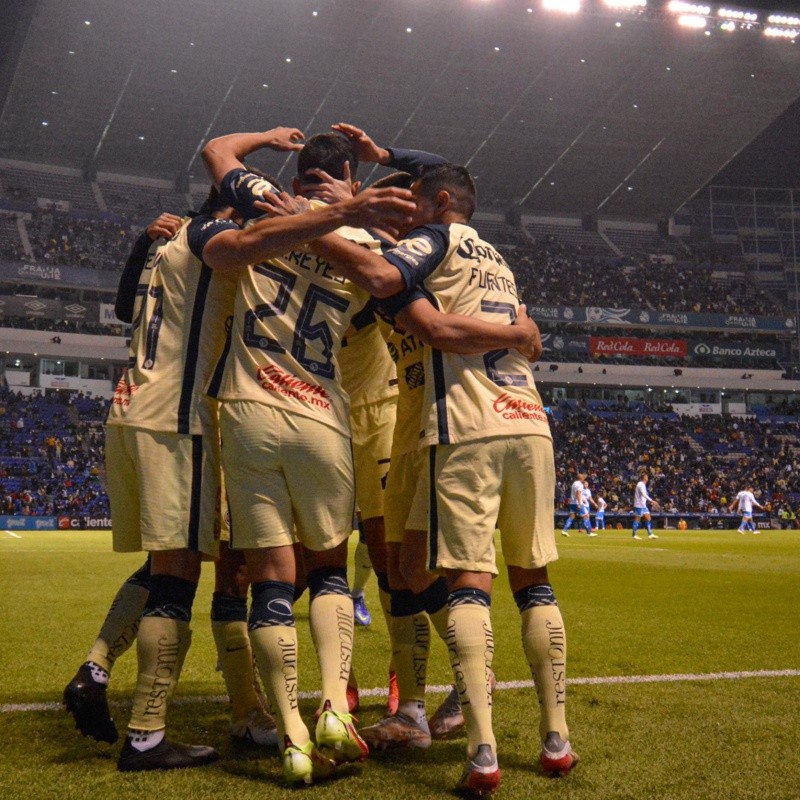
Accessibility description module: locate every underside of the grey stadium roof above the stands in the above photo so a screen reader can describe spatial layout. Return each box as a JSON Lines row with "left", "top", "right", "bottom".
{"left": 0, "top": 0, "right": 800, "bottom": 219}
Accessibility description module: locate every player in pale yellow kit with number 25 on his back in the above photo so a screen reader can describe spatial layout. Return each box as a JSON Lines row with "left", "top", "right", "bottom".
{"left": 203, "top": 131, "right": 411, "bottom": 783}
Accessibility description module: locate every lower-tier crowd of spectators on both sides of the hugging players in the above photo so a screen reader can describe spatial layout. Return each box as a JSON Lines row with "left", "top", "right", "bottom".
{"left": 0, "top": 388, "right": 800, "bottom": 517}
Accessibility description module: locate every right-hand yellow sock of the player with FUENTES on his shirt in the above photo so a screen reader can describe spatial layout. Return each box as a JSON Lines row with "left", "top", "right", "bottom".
{"left": 522, "top": 605, "right": 569, "bottom": 742}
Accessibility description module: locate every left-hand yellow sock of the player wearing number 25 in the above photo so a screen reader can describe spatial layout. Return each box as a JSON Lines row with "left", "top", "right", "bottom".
{"left": 250, "top": 625, "right": 310, "bottom": 750}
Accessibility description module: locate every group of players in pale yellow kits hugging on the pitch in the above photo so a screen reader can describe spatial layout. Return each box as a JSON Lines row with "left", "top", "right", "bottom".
{"left": 64, "top": 124, "right": 578, "bottom": 796}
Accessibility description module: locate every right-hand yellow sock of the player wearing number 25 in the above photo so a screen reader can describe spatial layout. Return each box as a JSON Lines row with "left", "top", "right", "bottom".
{"left": 309, "top": 594, "right": 353, "bottom": 714}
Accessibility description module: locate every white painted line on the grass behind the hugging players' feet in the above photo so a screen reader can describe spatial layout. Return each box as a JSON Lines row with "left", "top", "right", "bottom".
{"left": 0, "top": 669, "right": 800, "bottom": 714}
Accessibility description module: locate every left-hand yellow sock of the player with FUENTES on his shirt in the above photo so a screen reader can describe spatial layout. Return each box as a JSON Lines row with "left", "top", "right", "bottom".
{"left": 447, "top": 590, "right": 497, "bottom": 758}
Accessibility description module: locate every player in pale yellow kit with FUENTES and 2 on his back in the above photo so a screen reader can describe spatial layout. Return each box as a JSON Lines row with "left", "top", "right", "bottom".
{"left": 306, "top": 165, "right": 577, "bottom": 795}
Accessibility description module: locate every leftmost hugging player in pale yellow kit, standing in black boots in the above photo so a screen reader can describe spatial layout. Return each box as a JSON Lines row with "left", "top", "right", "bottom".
{"left": 106, "top": 126, "right": 410, "bottom": 770}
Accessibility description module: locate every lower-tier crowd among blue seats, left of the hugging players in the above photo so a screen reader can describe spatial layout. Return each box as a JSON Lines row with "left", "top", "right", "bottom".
{"left": 0, "top": 388, "right": 109, "bottom": 516}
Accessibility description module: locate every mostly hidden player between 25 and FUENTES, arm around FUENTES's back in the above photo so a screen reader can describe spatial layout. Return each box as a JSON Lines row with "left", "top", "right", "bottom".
{"left": 304, "top": 150, "right": 538, "bottom": 749}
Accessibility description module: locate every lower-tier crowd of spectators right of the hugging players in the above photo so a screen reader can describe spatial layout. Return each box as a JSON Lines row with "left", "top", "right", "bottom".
{"left": 552, "top": 408, "right": 800, "bottom": 514}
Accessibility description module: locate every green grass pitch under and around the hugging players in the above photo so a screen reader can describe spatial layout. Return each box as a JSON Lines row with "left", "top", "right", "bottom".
{"left": 0, "top": 531, "right": 800, "bottom": 800}
